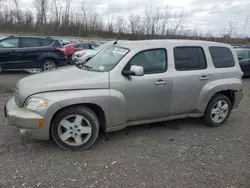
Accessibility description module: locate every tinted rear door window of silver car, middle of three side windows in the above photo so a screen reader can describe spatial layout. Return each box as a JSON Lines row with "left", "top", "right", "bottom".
{"left": 174, "top": 47, "right": 207, "bottom": 71}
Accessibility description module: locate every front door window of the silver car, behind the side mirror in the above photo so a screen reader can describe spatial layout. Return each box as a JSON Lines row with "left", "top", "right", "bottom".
{"left": 125, "top": 49, "right": 167, "bottom": 74}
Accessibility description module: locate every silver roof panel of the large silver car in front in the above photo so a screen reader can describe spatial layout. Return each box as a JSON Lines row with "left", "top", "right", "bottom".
{"left": 117, "top": 39, "right": 232, "bottom": 49}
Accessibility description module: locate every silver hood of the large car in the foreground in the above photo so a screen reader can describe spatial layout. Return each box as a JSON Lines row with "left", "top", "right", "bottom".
{"left": 17, "top": 66, "right": 109, "bottom": 104}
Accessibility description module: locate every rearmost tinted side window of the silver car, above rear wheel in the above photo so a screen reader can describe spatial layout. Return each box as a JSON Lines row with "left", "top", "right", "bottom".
{"left": 209, "top": 46, "right": 235, "bottom": 68}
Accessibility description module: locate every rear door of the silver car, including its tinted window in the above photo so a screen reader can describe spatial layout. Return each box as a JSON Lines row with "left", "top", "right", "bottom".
{"left": 170, "top": 46, "right": 210, "bottom": 115}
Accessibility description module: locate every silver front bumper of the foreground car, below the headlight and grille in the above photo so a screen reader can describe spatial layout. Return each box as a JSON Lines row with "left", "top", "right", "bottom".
{"left": 4, "top": 97, "right": 49, "bottom": 140}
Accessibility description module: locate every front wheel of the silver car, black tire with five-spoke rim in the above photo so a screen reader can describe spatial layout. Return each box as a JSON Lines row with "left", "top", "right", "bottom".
{"left": 51, "top": 106, "right": 99, "bottom": 151}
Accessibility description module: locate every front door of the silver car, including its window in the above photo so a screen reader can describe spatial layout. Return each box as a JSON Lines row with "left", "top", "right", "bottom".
{"left": 110, "top": 48, "right": 173, "bottom": 122}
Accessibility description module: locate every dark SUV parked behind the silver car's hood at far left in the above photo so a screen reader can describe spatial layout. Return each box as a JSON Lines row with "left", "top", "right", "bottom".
{"left": 0, "top": 36, "right": 67, "bottom": 72}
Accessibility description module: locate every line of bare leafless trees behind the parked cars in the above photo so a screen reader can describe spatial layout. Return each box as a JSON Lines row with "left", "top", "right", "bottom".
{"left": 0, "top": 0, "right": 249, "bottom": 43}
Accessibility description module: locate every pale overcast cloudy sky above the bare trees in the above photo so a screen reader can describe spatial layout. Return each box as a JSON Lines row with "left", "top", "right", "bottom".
{"left": 18, "top": 0, "right": 250, "bottom": 35}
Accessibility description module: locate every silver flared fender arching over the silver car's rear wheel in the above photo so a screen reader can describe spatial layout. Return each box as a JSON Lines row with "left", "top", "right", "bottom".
{"left": 196, "top": 78, "right": 243, "bottom": 113}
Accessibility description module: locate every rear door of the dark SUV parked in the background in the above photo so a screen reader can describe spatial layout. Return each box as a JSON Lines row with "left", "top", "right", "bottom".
{"left": 20, "top": 37, "right": 42, "bottom": 69}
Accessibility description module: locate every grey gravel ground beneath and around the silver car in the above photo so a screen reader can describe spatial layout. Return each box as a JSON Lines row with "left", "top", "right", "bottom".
{"left": 0, "top": 73, "right": 250, "bottom": 188}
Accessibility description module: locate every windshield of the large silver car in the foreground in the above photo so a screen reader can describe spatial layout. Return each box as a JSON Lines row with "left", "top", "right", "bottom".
{"left": 85, "top": 46, "right": 129, "bottom": 72}
